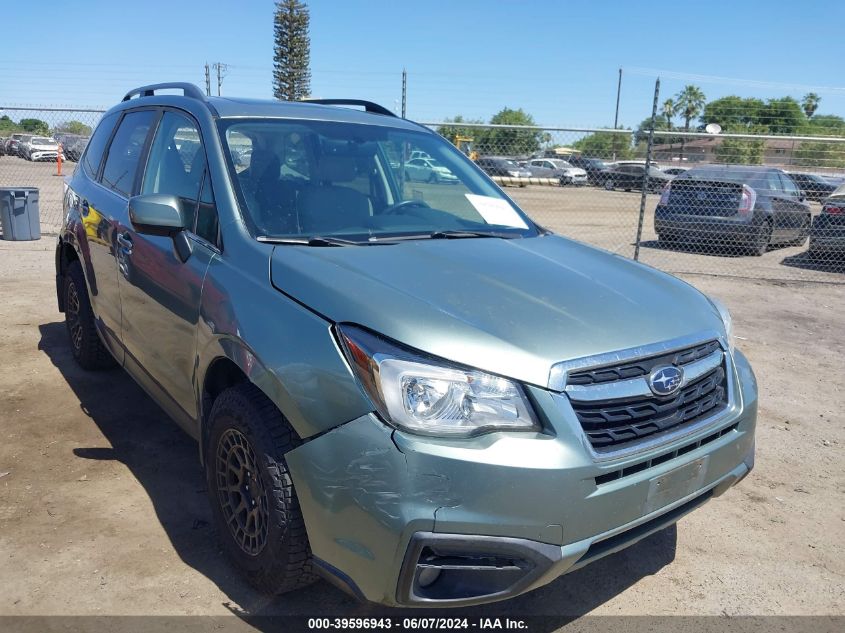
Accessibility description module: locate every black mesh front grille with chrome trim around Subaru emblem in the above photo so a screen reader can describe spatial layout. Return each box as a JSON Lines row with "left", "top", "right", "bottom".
{"left": 567, "top": 340, "right": 728, "bottom": 451}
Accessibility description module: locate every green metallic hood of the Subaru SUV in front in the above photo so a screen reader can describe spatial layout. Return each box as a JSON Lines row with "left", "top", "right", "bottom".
{"left": 270, "top": 235, "right": 723, "bottom": 386}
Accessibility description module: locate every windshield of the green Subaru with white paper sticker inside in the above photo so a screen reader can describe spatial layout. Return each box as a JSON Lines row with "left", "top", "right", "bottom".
{"left": 220, "top": 119, "right": 538, "bottom": 244}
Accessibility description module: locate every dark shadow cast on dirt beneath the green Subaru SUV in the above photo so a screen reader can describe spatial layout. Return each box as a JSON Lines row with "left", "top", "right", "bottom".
{"left": 38, "top": 322, "right": 677, "bottom": 630}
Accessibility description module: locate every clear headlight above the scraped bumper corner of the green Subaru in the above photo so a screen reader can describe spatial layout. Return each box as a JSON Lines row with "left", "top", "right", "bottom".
{"left": 337, "top": 325, "right": 539, "bottom": 437}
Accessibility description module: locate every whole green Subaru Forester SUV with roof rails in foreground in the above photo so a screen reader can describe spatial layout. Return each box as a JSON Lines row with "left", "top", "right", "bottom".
{"left": 56, "top": 84, "right": 757, "bottom": 606}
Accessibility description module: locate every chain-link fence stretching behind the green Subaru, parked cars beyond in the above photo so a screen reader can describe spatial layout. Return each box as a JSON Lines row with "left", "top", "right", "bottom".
{"left": 0, "top": 107, "right": 845, "bottom": 283}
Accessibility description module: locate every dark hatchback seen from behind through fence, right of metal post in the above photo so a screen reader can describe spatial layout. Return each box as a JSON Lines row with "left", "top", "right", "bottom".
{"left": 654, "top": 165, "right": 811, "bottom": 255}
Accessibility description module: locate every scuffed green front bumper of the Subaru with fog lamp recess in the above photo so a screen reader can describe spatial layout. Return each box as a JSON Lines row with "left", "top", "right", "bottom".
{"left": 286, "top": 352, "right": 757, "bottom": 606}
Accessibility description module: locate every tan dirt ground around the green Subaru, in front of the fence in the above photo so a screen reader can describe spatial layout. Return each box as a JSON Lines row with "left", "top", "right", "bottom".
{"left": 0, "top": 226, "right": 845, "bottom": 616}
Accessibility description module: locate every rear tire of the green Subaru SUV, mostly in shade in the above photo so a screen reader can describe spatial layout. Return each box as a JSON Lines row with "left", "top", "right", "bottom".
{"left": 62, "top": 260, "right": 117, "bottom": 371}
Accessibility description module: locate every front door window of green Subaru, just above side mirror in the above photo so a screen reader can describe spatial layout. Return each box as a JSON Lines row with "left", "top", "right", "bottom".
{"left": 141, "top": 111, "right": 210, "bottom": 238}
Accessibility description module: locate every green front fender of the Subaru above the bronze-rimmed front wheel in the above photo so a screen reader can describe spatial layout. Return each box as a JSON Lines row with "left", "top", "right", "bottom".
{"left": 197, "top": 246, "right": 372, "bottom": 439}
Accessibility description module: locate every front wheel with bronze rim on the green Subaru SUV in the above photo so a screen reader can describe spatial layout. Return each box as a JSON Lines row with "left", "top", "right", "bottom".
{"left": 205, "top": 383, "right": 317, "bottom": 594}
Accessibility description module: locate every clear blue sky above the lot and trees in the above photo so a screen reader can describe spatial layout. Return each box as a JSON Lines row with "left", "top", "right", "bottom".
{"left": 0, "top": 0, "right": 845, "bottom": 127}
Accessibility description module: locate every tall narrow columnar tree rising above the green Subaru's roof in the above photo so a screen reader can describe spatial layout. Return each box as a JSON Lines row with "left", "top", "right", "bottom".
{"left": 273, "top": 0, "right": 311, "bottom": 101}
